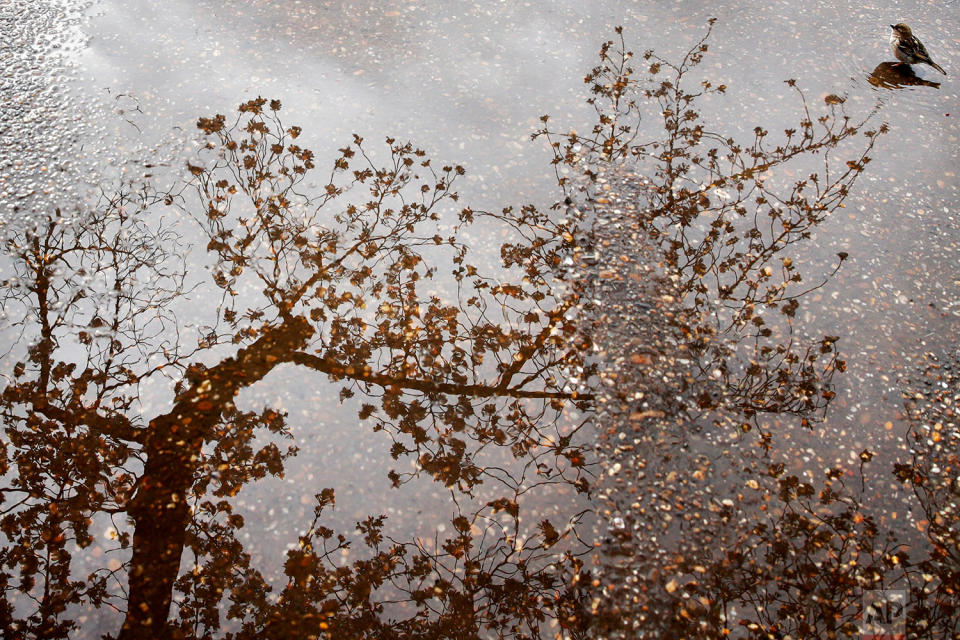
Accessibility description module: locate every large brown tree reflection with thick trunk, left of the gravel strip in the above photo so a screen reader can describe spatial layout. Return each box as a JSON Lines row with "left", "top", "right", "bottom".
{"left": 0, "top": 99, "right": 589, "bottom": 638}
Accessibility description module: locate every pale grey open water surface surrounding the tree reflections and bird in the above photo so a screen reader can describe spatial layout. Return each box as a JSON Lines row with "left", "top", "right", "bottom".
{"left": 0, "top": 0, "right": 960, "bottom": 636}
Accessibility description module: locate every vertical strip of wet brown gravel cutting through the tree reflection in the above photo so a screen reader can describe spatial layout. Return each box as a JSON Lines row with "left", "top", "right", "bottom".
{"left": 568, "top": 169, "right": 726, "bottom": 637}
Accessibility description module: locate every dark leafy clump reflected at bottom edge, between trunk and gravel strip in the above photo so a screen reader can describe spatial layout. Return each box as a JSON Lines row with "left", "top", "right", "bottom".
{"left": 241, "top": 484, "right": 585, "bottom": 638}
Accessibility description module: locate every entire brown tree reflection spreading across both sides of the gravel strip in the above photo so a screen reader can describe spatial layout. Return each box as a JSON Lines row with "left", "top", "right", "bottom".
{"left": 0, "top": 20, "right": 960, "bottom": 639}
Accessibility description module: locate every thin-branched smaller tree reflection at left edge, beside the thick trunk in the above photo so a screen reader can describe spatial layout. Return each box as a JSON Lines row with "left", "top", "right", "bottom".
{"left": 2, "top": 194, "right": 191, "bottom": 637}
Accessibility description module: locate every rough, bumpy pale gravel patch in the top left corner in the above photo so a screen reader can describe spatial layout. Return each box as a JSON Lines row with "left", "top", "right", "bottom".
{"left": 0, "top": 0, "right": 196, "bottom": 225}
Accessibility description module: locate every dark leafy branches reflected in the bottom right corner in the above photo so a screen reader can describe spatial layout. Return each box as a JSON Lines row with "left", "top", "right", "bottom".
{"left": 632, "top": 356, "right": 960, "bottom": 639}
